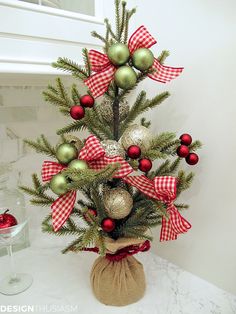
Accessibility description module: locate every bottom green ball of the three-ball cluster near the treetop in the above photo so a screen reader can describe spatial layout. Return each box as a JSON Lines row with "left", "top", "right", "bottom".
{"left": 115, "top": 65, "right": 137, "bottom": 89}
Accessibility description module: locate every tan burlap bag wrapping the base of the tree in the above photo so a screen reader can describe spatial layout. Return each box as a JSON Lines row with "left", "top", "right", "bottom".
{"left": 90, "top": 238, "right": 146, "bottom": 306}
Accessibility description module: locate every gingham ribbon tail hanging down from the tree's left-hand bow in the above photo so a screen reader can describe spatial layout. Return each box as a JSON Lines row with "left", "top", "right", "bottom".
{"left": 51, "top": 191, "right": 76, "bottom": 232}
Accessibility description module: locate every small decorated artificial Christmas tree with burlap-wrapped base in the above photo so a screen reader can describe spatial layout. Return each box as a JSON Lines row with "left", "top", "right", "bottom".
{"left": 22, "top": 0, "right": 201, "bottom": 305}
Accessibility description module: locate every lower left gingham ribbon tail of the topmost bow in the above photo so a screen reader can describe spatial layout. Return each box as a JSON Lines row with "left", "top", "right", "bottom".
{"left": 84, "top": 65, "right": 116, "bottom": 98}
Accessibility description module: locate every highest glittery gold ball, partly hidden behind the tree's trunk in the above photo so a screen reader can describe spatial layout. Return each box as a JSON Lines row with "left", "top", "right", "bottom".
{"left": 97, "top": 98, "right": 129, "bottom": 122}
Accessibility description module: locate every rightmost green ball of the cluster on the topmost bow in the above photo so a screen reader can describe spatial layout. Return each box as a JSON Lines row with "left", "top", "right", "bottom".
{"left": 132, "top": 48, "right": 154, "bottom": 71}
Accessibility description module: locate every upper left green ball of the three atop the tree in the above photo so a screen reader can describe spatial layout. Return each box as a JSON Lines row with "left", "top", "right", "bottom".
{"left": 107, "top": 43, "right": 130, "bottom": 65}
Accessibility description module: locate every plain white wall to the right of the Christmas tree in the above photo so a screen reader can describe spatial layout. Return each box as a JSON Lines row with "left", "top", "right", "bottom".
{"left": 106, "top": 0, "right": 236, "bottom": 293}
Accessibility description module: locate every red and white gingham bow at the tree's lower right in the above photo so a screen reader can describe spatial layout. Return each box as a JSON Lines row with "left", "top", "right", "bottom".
{"left": 123, "top": 175, "right": 191, "bottom": 241}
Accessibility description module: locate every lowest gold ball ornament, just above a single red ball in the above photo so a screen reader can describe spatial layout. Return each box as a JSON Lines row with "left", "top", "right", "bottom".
{"left": 104, "top": 188, "right": 133, "bottom": 219}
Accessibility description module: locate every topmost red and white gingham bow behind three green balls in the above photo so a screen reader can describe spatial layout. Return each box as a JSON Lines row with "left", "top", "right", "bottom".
{"left": 85, "top": 25, "right": 183, "bottom": 98}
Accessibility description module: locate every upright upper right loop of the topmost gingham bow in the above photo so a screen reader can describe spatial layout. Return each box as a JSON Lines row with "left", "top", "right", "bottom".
{"left": 128, "top": 25, "right": 157, "bottom": 54}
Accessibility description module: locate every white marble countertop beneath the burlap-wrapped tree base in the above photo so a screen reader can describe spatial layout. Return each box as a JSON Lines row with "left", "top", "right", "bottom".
{"left": 0, "top": 238, "right": 236, "bottom": 314}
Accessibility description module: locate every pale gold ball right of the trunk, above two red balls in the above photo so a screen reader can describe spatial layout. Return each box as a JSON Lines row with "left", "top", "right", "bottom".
{"left": 120, "top": 124, "right": 153, "bottom": 153}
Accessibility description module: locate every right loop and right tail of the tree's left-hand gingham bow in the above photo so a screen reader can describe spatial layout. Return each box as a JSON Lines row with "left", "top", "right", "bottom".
{"left": 79, "top": 135, "right": 133, "bottom": 178}
